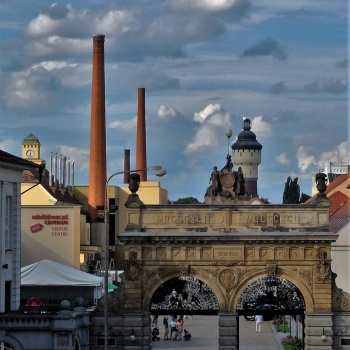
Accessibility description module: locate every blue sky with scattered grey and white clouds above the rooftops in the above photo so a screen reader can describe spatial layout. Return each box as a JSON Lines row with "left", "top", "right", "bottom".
{"left": 0, "top": 0, "right": 350, "bottom": 204}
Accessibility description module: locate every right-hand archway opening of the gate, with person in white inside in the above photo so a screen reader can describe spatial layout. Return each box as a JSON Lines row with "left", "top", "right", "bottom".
{"left": 236, "top": 276, "right": 305, "bottom": 349}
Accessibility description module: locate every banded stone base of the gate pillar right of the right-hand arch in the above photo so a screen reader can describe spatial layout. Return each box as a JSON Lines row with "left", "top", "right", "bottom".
{"left": 305, "top": 312, "right": 333, "bottom": 350}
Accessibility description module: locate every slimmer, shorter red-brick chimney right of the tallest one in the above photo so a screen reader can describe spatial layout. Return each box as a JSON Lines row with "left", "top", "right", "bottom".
{"left": 136, "top": 88, "right": 147, "bottom": 181}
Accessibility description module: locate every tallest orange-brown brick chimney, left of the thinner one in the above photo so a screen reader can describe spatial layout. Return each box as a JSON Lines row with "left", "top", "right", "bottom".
{"left": 89, "top": 35, "right": 107, "bottom": 222}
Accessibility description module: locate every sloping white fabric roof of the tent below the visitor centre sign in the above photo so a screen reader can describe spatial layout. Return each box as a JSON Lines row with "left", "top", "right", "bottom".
{"left": 21, "top": 260, "right": 101, "bottom": 286}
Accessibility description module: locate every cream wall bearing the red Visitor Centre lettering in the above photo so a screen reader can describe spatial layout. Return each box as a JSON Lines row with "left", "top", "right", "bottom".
{"left": 21, "top": 205, "right": 80, "bottom": 269}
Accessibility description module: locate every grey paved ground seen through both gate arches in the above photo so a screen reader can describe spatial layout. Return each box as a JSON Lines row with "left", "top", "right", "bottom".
{"left": 152, "top": 316, "right": 283, "bottom": 350}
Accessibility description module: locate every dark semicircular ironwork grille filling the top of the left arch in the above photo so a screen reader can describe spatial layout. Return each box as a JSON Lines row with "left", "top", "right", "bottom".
{"left": 150, "top": 276, "right": 219, "bottom": 315}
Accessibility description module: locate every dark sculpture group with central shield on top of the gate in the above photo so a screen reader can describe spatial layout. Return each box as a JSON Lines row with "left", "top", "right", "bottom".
{"left": 205, "top": 155, "right": 249, "bottom": 201}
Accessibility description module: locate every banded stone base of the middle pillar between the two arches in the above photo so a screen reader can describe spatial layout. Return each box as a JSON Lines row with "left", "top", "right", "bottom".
{"left": 219, "top": 312, "right": 237, "bottom": 350}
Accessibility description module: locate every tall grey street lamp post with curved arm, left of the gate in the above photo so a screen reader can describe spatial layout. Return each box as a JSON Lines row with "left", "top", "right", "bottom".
{"left": 104, "top": 165, "right": 166, "bottom": 350}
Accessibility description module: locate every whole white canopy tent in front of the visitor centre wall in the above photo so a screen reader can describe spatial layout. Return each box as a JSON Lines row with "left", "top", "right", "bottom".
{"left": 21, "top": 260, "right": 102, "bottom": 304}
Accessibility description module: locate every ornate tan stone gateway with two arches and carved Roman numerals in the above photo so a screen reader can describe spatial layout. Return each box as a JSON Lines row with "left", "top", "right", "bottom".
{"left": 91, "top": 175, "right": 350, "bottom": 350}
